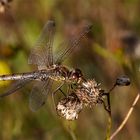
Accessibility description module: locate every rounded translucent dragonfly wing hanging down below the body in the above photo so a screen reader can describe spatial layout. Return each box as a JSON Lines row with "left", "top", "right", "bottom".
{"left": 29, "top": 79, "right": 53, "bottom": 112}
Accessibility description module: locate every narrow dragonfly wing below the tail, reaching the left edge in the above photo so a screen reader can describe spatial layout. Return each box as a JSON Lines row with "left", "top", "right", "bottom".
{"left": 0, "top": 79, "right": 31, "bottom": 98}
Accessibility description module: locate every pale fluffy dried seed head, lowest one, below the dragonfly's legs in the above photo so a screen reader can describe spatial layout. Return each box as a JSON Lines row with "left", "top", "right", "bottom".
{"left": 56, "top": 93, "right": 82, "bottom": 120}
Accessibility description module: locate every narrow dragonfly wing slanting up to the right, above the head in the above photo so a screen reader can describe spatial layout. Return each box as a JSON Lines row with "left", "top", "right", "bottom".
{"left": 56, "top": 25, "right": 92, "bottom": 64}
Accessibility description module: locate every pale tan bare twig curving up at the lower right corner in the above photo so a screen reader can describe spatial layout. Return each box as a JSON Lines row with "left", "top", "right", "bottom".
{"left": 110, "top": 93, "right": 140, "bottom": 140}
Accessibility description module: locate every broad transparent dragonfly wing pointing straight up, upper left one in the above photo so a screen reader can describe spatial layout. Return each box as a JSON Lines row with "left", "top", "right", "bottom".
{"left": 28, "top": 21, "right": 55, "bottom": 67}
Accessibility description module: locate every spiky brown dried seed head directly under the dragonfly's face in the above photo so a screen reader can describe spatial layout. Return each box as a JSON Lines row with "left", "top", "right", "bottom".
{"left": 75, "top": 80, "right": 102, "bottom": 107}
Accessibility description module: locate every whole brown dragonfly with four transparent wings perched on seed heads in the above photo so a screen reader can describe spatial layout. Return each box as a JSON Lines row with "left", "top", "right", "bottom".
{"left": 0, "top": 20, "right": 92, "bottom": 111}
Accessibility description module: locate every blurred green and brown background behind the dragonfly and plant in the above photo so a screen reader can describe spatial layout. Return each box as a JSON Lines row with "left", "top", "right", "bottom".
{"left": 0, "top": 0, "right": 140, "bottom": 140}
